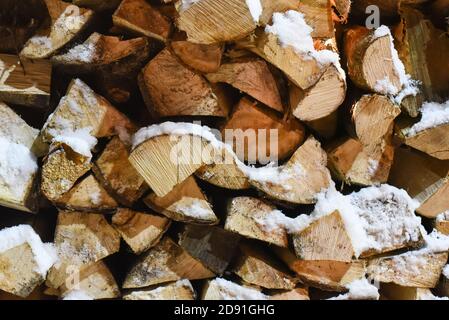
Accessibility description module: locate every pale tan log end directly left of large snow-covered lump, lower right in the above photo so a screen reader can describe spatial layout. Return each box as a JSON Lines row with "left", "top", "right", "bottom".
{"left": 293, "top": 211, "right": 354, "bottom": 262}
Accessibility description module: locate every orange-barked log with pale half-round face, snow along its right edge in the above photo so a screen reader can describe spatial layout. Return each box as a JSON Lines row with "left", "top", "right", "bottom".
{"left": 344, "top": 26, "right": 402, "bottom": 93}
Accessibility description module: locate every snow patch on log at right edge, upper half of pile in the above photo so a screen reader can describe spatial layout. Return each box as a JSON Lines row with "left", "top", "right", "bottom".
{"left": 404, "top": 100, "right": 449, "bottom": 137}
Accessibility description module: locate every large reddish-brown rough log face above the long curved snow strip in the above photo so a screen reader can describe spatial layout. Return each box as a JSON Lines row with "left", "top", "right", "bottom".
{"left": 139, "top": 49, "right": 228, "bottom": 117}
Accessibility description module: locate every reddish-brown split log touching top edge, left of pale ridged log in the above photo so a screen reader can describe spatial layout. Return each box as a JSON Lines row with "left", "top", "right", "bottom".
{"left": 112, "top": 0, "right": 171, "bottom": 41}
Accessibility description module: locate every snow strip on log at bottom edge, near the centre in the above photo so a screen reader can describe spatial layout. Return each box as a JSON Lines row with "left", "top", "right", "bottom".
{"left": 209, "top": 278, "right": 268, "bottom": 300}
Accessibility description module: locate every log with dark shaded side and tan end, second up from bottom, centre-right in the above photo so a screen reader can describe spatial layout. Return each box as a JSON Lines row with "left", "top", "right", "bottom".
{"left": 232, "top": 243, "right": 297, "bottom": 290}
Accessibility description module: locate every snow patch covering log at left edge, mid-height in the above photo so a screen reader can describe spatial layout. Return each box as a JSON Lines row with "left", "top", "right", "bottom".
{"left": 0, "top": 137, "right": 38, "bottom": 199}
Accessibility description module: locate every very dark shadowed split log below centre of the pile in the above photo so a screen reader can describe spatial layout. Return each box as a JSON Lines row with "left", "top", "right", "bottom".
{"left": 179, "top": 225, "right": 240, "bottom": 274}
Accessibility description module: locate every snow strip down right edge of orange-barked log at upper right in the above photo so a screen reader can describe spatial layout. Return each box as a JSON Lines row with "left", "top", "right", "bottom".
{"left": 373, "top": 25, "right": 419, "bottom": 104}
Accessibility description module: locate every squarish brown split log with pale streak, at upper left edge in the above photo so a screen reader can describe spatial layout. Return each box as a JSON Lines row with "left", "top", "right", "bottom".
{"left": 0, "top": 54, "right": 51, "bottom": 109}
